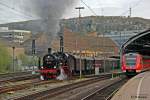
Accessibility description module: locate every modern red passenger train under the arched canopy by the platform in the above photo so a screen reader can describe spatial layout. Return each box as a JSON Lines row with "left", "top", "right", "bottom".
{"left": 122, "top": 53, "right": 150, "bottom": 76}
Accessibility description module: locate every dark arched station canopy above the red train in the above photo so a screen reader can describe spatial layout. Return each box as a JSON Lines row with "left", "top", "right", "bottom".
{"left": 121, "top": 29, "right": 150, "bottom": 56}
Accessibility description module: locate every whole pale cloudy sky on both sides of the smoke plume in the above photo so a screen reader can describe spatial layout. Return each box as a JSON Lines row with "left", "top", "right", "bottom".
{"left": 0, "top": 0, "right": 150, "bottom": 23}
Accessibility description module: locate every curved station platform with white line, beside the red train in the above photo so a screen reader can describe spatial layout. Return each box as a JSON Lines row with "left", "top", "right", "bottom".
{"left": 111, "top": 71, "right": 150, "bottom": 100}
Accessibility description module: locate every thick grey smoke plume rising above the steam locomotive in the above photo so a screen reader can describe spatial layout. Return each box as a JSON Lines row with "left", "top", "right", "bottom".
{"left": 22, "top": 0, "right": 78, "bottom": 43}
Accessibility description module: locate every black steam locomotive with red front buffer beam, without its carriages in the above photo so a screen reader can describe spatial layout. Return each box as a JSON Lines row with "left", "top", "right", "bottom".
{"left": 39, "top": 48, "right": 70, "bottom": 80}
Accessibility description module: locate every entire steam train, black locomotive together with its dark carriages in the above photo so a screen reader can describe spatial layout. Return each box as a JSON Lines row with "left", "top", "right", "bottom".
{"left": 39, "top": 49, "right": 120, "bottom": 80}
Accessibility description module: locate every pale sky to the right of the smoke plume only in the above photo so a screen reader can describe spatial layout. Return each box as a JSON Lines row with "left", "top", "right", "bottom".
{"left": 64, "top": 0, "right": 150, "bottom": 19}
